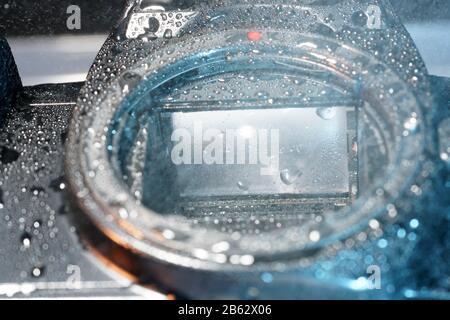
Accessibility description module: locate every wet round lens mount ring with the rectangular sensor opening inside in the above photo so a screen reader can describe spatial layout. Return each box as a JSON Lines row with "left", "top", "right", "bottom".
{"left": 66, "top": 30, "right": 425, "bottom": 270}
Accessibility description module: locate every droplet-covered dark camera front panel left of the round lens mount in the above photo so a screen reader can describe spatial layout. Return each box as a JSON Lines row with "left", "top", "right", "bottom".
{"left": 0, "top": 84, "right": 163, "bottom": 298}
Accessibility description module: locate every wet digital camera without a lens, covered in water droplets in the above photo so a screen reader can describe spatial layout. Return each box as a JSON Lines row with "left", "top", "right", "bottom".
{"left": 0, "top": 0, "right": 450, "bottom": 299}
